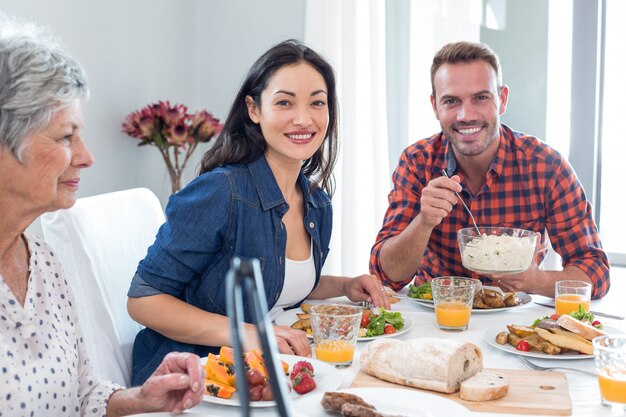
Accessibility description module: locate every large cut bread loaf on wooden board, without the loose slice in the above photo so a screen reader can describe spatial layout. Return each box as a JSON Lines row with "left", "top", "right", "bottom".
{"left": 361, "top": 338, "right": 483, "bottom": 393}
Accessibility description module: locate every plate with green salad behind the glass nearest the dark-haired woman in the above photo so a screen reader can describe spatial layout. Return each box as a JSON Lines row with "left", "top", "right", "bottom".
{"left": 274, "top": 303, "right": 412, "bottom": 342}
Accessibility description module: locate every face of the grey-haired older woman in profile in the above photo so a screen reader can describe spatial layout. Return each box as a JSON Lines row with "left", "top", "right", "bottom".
{"left": 0, "top": 100, "right": 93, "bottom": 213}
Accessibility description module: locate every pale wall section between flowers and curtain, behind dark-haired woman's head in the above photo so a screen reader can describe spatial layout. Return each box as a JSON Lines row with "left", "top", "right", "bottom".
{"left": 190, "top": 0, "right": 306, "bottom": 187}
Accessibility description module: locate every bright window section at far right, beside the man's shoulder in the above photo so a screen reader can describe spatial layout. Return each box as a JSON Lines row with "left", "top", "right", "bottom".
{"left": 551, "top": 0, "right": 626, "bottom": 266}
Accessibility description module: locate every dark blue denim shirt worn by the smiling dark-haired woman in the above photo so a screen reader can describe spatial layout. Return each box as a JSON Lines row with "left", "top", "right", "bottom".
{"left": 128, "top": 156, "right": 332, "bottom": 385}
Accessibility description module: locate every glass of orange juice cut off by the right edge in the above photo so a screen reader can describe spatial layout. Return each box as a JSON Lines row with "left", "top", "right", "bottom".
{"left": 592, "top": 336, "right": 626, "bottom": 412}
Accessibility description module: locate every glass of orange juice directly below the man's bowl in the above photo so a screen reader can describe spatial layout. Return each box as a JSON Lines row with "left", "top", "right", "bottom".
{"left": 430, "top": 276, "right": 478, "bottom": 330}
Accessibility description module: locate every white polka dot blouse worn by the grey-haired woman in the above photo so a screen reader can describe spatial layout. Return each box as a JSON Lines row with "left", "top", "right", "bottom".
{"left": 0, "top": 234, "right": 119, "bottom": 417}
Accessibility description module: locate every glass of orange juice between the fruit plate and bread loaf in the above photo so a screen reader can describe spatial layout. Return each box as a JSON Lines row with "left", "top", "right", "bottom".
{"left": 310, "top": 304, "right": 363, "bottom": 367}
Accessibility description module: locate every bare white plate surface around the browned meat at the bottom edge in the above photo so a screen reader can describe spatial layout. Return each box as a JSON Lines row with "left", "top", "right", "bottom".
{"left": 294, "top": 387, "right": 472, "bottom": 417}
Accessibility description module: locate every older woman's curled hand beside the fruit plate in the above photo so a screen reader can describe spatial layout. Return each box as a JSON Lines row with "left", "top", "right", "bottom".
{"left": 138, "top": 352, "right": 205, "bottom": 414}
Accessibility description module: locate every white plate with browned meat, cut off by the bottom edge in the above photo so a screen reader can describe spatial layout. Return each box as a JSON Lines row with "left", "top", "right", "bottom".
{"left": 294, "top": 387, "right": 472, "bottom": 417}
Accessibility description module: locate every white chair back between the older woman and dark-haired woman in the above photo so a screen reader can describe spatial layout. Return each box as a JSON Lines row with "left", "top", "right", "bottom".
{"left": 41, "top": 188, "right": 165, "bottom": 386}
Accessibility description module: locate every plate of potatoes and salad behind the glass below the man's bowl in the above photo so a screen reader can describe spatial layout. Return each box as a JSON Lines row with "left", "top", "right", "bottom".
{"left": 402, "top": 282, "right": 532, "bottom": 313}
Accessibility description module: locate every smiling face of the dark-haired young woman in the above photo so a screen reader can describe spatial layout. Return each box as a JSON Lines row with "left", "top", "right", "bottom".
{"left": 246, "top": 62, "right": 329, "bottom": 165}
